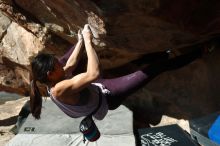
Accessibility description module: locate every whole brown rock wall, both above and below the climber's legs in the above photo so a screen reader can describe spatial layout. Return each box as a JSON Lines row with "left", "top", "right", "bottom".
{"left": 0, "top": 0, "right": 220, "bottom": 144}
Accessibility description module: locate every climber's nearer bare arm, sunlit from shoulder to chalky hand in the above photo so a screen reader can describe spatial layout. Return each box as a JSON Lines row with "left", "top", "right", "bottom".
{"left": 53, "top": 25, "right": 100, "bottom": 98}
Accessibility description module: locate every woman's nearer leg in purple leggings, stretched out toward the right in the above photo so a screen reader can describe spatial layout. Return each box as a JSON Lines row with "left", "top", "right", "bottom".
{"left": 96, "top": 48, "right": 203, "bottom": 110}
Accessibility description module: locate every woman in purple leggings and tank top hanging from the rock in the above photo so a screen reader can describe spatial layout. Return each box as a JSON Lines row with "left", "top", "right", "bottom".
{"left": 30, "top": 25, "right": 207, "bottom": 120}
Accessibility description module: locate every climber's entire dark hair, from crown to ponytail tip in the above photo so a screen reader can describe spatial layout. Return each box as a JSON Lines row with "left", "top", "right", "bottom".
{"left": 30, "top": 53, "right": 56, "bottom": 119}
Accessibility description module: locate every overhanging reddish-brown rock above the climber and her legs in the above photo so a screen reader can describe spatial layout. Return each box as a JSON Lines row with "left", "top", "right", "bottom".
{"left": 0, "top": 0, "right": 220, "bottom": 101}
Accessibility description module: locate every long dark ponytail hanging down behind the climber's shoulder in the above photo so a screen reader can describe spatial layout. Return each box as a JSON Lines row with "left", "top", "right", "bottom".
{"left": 30, "top": 79, "right": 42, "bottom": 119}
